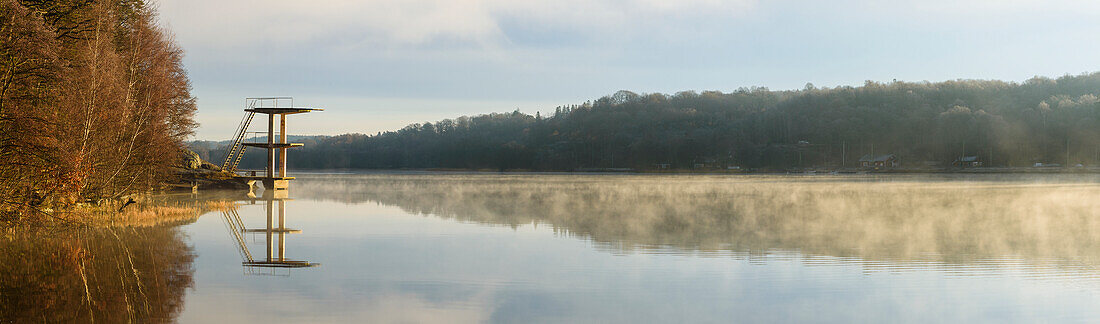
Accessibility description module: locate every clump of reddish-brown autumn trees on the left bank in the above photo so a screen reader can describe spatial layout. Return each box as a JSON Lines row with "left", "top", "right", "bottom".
{"left": 0, "top": 0, "right": 195, "bottom": 223}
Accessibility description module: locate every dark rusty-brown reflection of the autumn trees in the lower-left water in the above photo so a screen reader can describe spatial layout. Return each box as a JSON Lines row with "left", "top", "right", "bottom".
{"left": 0, "top": 223, "right": 195, "bottom": 323}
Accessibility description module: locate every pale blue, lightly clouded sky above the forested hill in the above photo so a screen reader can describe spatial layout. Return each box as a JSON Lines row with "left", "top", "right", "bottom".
{"left": 156, "top": 0, "right": 1100, "bottom": 141}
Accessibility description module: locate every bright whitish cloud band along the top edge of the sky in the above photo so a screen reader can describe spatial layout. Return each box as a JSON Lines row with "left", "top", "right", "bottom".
{"left": 161, "top": 0, "right": 755, "bottom": 46}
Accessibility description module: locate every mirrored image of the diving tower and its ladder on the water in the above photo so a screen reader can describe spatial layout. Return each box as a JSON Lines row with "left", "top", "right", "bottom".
{"left": 222, "top": 199, "right": 318, "bottom": 273}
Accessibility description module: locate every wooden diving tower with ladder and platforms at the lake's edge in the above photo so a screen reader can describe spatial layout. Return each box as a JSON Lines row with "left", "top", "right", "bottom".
{"left": 222, "top": 97, "right": 323, "bottom": 190}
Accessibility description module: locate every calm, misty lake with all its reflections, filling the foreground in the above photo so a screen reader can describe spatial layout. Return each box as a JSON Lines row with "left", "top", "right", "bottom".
{"left": 0, "top": 172, "right": 1100, "bottom": 323}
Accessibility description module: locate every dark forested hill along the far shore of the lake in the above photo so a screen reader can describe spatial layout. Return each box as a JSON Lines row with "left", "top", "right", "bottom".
{"left": 202, "top": 74, "right": 1100, "bottom": 170}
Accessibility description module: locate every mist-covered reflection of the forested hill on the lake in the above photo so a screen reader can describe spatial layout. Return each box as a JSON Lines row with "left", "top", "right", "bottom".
{"left": 297, "top": 175, "right": 1100, "bottom": 277}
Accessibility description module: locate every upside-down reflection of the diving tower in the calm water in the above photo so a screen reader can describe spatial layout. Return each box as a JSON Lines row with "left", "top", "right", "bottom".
{"left": 221, "top": 194, "right": 319, "bottom": 275}
